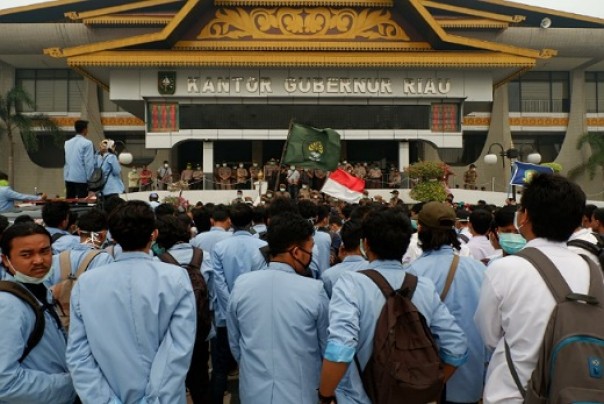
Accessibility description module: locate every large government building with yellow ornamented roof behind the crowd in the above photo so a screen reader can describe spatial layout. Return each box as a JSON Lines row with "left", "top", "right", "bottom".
{"left": 0, "top": 0, "right": 604, "bottom": 200}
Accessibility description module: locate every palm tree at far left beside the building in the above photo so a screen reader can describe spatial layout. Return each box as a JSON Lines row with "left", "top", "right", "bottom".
{"left": 0, "top": 87, "right": 63, "bottom": 182}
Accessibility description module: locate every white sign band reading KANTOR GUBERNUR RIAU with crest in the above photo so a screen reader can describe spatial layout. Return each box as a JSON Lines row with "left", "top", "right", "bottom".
{"left": 110, "top": 69, "right": 493, "bottom": 102}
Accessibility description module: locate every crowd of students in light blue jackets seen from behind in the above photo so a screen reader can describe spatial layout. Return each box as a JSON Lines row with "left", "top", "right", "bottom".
{"left": 0, "top": 175, "right": 604, "bottom": 404}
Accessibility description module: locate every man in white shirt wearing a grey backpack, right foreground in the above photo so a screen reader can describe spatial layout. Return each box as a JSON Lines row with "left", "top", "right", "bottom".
{"left": 474, "top": 174, "right": 589, "bottom": 404}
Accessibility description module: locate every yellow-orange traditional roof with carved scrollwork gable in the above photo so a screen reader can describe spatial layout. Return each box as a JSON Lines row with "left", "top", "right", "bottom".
{"left": 8, "top": 0, "right": 604, "bottom": 89}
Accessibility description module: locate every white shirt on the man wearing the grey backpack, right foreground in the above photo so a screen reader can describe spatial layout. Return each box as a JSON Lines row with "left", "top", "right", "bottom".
{"left": 474, "top": 238, "right": 589, "bottom": 404}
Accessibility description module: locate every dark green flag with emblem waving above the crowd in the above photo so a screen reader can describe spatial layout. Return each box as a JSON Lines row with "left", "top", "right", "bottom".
{"left": 282, "top": 123, "right": 340, "bottom": 171}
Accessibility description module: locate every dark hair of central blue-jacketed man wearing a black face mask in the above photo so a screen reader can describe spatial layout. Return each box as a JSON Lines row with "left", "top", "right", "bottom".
{"left": 266, "top": 212, "right": 315, "bottom": 255}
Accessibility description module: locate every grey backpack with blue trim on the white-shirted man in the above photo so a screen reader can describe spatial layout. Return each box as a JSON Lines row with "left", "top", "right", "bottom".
{"left": 505, "top": 248, "right": 604, "bottom": 404}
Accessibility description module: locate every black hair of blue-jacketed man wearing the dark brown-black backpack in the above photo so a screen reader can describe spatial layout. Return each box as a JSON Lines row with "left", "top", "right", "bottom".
{"left": 363, "top": 209, "right": 413, "bottom": 261}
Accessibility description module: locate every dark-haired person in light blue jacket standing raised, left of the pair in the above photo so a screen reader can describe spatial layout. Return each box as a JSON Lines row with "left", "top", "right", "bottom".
{"left": 63, "top": 120, "right": 94, "bottom": 199}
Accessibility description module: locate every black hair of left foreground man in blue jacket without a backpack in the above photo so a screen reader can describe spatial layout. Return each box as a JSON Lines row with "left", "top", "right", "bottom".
{"left": 109, "top": 201, "right": 155, "bottom": 251}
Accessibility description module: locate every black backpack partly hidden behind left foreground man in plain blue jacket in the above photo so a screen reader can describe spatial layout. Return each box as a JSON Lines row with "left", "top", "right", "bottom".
{"left": 158, "top": 247, "right": 212, "bottom": 342}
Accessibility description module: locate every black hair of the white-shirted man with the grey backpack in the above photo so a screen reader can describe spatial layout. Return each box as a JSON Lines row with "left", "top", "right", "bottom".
{"left": 520, "top": 174, "right": 585, "bottom": 242}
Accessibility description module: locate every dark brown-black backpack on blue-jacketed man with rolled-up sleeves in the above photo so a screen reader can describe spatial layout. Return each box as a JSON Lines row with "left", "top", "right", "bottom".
{"left": 355, "top": 269, "right": 445, "bottom": 404}
